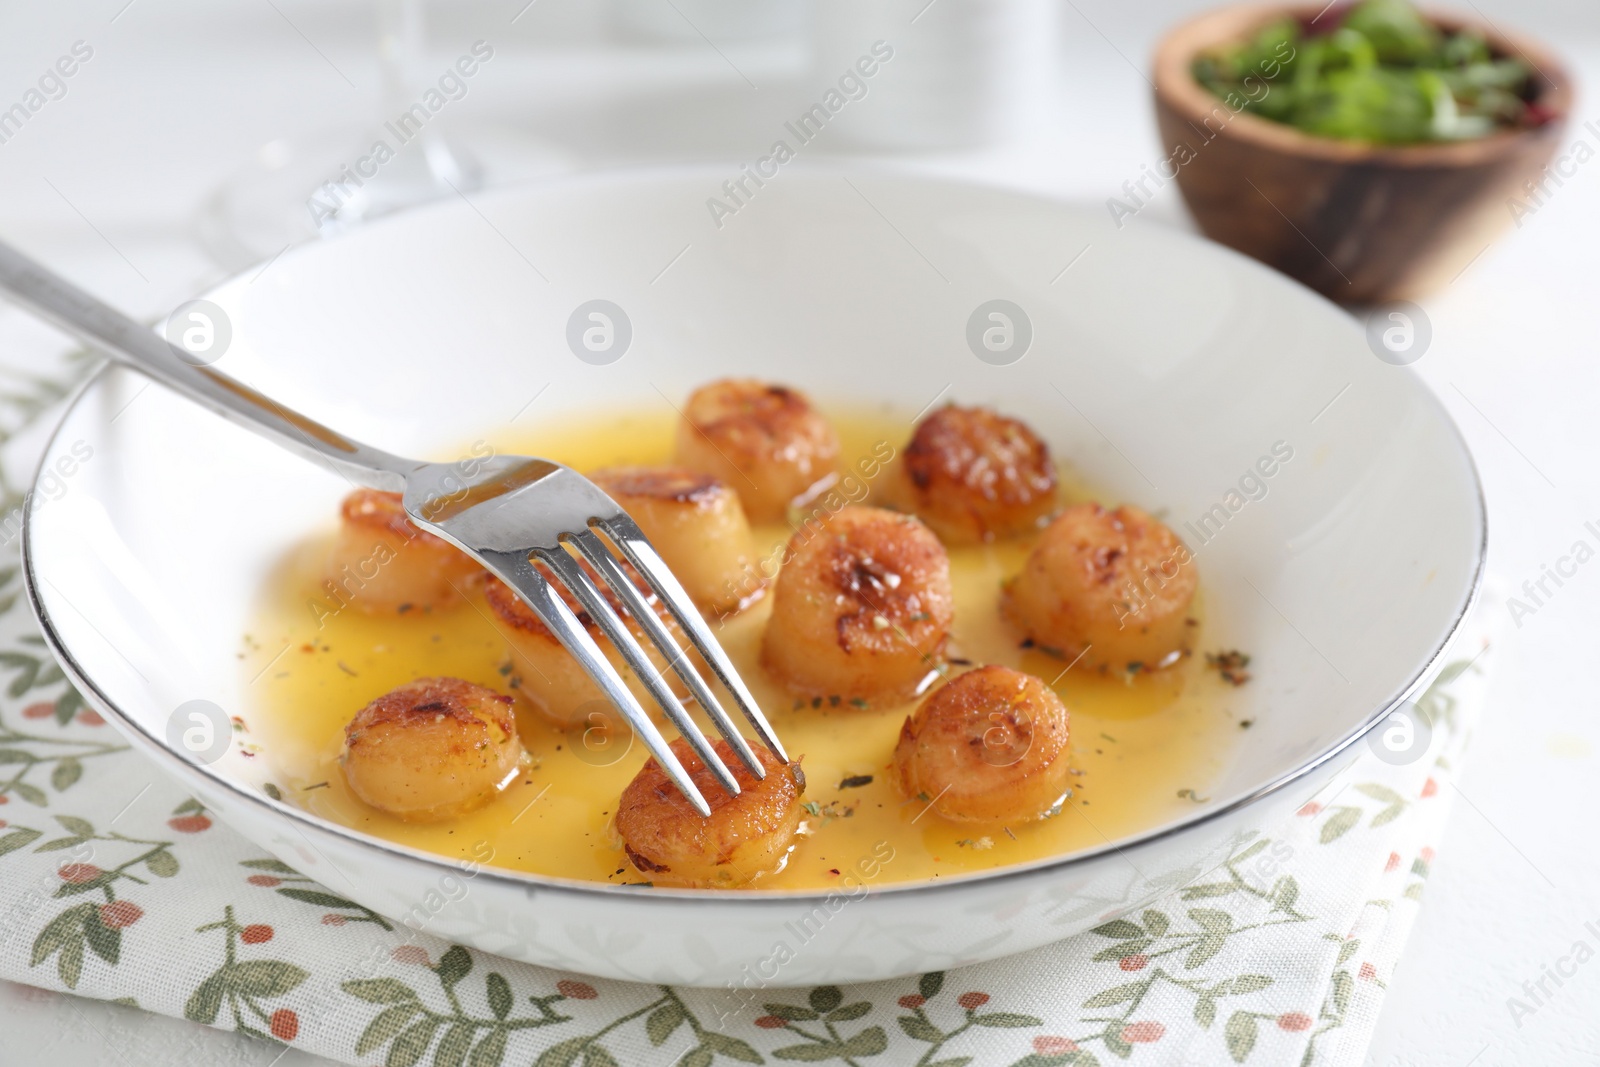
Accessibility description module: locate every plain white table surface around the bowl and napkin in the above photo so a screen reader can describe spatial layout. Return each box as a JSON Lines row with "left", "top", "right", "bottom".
{"left": 0, "top": 0, "right": 1600, "bottom": 1067}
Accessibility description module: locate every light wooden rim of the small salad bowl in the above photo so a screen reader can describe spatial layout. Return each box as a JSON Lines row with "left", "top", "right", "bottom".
{"left": 1150, "top": 0, "right": 1574, "bottom": 168}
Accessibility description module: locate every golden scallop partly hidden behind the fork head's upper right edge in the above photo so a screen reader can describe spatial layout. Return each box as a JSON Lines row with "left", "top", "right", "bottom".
{"left": 589, "top": 467, "right": 766, "bottom": 616}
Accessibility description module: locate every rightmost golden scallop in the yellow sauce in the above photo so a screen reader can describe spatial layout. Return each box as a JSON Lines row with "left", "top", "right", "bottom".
{"left": 1002, "top": 504, "right": 1198, "bottom": 670}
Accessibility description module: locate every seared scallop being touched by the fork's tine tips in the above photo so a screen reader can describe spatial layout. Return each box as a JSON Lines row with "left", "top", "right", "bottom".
{"left": 616, "top": 737, "right": 805, "bottom": 888}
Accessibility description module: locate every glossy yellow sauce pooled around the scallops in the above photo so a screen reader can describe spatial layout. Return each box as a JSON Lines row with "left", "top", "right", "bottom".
{"left": 242, "top": 410, "right": 1240, "bottom": 889}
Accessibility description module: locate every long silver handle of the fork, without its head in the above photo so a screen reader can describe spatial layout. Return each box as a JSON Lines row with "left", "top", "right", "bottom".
{"left": 0, "top": 242, "right": 418, "bottom": 493}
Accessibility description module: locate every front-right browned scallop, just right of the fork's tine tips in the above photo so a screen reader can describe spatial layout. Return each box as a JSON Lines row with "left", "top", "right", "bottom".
{"left": 894, "top": 665, "right": 1070, "bottom": 822}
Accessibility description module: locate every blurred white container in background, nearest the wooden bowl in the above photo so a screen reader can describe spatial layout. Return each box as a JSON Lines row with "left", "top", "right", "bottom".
{"left": 813, "top": 0, "right": 1054, "bottom": 150}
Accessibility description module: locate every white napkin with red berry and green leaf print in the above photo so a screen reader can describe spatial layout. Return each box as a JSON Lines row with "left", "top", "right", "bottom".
{"left": 0, "top": 351, "right": 1504, "bottom": 1067}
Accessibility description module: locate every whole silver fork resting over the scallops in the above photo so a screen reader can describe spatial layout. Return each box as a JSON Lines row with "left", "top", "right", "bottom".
{"left": 0, "top": 243, "right": 789, "bottom": 816}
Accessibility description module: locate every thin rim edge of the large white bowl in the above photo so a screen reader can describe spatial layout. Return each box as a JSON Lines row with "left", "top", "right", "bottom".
{"left": 21, "top": 163, "right": 1488, "bottom": 910}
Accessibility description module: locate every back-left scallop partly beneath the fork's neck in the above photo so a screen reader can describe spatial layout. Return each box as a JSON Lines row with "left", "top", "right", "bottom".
{"left": 323, "top": 490, "right": 483, "bottom": 614}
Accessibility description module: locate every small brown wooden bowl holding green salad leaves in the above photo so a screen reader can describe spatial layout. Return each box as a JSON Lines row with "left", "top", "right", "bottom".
{"left": 1152, "top": 5, "right": 1573, "bottom": 304}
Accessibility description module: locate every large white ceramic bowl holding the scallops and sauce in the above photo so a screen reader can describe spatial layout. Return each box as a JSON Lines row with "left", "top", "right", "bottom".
{"left": 26, "top": 165, "right": 1485, "bottom": 985}
